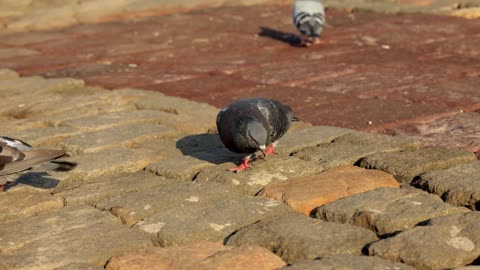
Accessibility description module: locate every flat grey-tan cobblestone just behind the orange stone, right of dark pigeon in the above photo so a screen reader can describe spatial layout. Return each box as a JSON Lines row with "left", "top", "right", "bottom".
{"left": 293, "top": 131, "right": 419, "bottom": 168}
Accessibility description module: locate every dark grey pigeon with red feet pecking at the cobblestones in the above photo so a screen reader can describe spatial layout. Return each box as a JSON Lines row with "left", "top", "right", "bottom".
{"left": 217, "top": 98, "right": 297, "bottom": 172}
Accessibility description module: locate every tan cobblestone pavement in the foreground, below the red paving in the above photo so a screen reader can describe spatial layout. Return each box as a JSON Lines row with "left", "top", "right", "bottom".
{"left": 0, "top": 69, "right": 480, "bottom": 269}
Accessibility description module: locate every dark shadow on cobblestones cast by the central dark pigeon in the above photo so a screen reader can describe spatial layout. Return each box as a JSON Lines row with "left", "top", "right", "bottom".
{"left": 176, "top": 133, "right": 244, "bottom": 164}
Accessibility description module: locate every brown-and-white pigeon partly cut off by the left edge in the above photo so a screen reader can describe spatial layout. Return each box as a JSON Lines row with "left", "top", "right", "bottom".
{"left": 0, "top": 136, "right": 76, "bottom": 192}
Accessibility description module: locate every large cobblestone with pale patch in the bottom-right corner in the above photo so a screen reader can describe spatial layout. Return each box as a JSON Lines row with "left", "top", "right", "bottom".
{"left": 368, "top": 211, "right": 480, "bottom": 269}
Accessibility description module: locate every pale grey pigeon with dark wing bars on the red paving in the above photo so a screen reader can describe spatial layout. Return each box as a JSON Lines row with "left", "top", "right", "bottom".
{"left": 292, "top": 0, "right": 325, "bottom": 47}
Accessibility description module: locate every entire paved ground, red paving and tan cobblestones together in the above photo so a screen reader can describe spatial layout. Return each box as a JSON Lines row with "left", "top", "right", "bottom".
{"left": 0, "top": 2, "right": 480, "bottom": 269}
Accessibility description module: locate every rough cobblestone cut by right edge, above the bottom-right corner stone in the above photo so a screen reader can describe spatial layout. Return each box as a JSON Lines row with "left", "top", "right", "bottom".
{"left": 412, "top": 160, "right": 480, "bottom": 210}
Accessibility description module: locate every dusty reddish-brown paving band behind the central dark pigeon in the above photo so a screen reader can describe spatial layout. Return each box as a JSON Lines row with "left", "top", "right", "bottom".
{"left": 0, "top": 6, "right": 480, "bottom": 154}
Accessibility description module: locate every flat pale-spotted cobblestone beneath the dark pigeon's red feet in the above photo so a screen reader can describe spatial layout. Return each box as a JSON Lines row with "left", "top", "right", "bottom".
{"left": 195, "top": 155, "right": 324, "bottom": 195}
